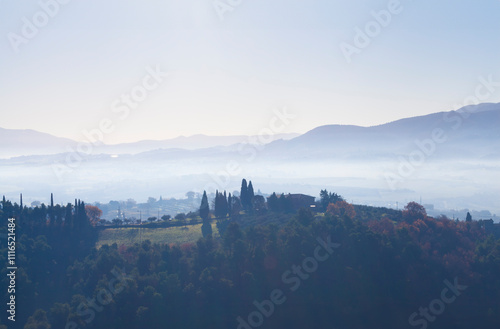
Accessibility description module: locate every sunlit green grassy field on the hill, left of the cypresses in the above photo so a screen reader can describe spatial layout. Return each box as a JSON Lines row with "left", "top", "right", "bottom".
{"left": 96, "top": 222, "right": 219, "bottom": 248}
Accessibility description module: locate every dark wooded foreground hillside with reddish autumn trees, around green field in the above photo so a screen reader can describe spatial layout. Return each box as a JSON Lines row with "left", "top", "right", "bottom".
{"left": 0, "top": 186, "right": 500, "bottom": 329}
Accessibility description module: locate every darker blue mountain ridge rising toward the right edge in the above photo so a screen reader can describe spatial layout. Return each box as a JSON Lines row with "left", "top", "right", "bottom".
{"left": 265, "top": 103, "right": 500, "bottom": 159}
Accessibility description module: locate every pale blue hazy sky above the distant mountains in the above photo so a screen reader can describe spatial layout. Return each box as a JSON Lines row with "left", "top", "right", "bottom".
{"left": 0, "top": 0, "right": 500, "bottom": 143}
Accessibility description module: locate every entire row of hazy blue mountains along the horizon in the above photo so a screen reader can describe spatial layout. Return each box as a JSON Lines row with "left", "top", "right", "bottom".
{"left": 0, "top": 103, "right": 500, "bottom": 160}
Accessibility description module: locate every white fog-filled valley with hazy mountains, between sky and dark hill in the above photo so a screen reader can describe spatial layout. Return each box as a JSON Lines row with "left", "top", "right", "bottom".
{"left": 0, "top": 104, "right": 500, "bottom": 214}
